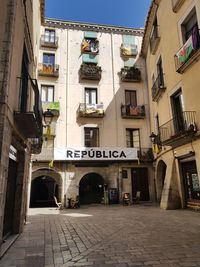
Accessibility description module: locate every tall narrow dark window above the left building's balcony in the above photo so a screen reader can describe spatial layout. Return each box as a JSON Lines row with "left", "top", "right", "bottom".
{"left": 19, "top": 46, "right": 29, "bottom": 112}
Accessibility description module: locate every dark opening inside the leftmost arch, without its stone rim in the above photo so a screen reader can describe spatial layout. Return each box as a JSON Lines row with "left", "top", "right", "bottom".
{"left": 30, "top": 176, "right": 58, "bottom": 208}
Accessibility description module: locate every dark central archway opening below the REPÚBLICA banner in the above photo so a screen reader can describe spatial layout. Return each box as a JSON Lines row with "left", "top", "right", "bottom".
{"left": 79, "top": 173, "right": 104, "bottom": 204}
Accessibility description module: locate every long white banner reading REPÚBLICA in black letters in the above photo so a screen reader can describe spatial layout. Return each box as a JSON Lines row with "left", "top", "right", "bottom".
{"left": 54, "top": 147, "right": 138, "bottom": 161}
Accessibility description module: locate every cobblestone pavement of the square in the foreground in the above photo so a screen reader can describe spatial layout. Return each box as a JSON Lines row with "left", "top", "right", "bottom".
{"left": 0, "top": 204, "right": 200, "bottom": 267}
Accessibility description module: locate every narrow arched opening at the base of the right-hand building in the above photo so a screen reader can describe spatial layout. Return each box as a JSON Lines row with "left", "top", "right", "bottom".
{"left": 156, "top": 160, "right": 167, "bottom": 202}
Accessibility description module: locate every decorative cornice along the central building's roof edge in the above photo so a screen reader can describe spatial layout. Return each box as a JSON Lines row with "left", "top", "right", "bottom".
{"left": 44, "top": 19, "right": 144, "bottom": 36}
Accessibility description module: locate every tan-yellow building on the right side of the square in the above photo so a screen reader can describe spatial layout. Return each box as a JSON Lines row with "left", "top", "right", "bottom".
{"left": 142, "top": 0, "right": 200, "bottom": 209}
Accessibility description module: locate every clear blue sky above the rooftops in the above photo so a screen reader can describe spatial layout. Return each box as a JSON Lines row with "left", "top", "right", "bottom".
{"left": 45, "top": 0, "right": 151, "bottom": 28}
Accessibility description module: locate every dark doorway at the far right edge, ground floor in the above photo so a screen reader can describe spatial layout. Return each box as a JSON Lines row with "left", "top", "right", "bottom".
{"left": 181, "top": 160, "right": 200, "bottom": 206}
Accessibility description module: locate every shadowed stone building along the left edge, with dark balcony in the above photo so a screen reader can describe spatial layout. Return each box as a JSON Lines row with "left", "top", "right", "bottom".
{"left": 0, "top": 0, "right": 44, "bottom": 256}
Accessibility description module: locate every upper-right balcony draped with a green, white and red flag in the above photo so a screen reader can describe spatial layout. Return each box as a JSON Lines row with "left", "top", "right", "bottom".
{"left": 174, "top": 27, "right": 200, "bottom": 74}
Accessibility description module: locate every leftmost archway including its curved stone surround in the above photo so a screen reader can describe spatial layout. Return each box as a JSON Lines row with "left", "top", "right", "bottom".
{"left": 30, "top": 169, "right": 62, "bottom": 208}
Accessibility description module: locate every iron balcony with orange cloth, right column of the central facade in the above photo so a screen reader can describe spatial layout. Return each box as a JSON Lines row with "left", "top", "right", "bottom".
{"left": 121, "top": 105, "right": 145, "bottom": 119}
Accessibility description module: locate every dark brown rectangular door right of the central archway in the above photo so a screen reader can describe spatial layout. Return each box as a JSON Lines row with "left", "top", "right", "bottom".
{"left": 131, "top": 168, "right": 149, "bottom": 201}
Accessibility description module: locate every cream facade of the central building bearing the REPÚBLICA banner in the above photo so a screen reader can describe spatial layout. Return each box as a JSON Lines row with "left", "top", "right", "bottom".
{"left": 30, "top": 19, "right": 155, "bottom": 207}
